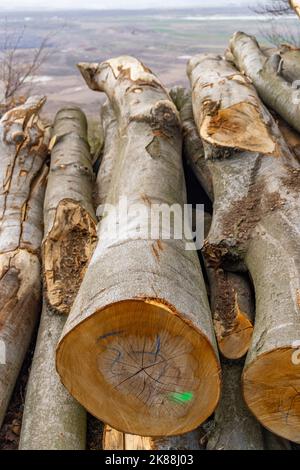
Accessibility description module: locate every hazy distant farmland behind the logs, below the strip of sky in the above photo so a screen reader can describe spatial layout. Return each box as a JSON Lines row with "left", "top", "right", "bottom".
{"left": 0, "top": 10, "right": 298, "bottom": 114}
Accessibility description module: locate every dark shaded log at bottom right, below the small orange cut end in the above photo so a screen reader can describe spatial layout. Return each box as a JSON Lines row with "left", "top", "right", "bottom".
{"left": 206, "top": 364, "right": 264, "bottom": 450}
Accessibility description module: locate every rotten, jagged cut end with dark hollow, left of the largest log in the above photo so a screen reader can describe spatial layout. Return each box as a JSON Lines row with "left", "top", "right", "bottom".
{"left": 43, "top": 200, "right": 96, "bottom": 314}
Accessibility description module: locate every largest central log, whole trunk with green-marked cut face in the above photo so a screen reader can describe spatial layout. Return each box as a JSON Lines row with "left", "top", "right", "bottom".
{"left": 57, "top": 57, "right": 220, "bottom": 436}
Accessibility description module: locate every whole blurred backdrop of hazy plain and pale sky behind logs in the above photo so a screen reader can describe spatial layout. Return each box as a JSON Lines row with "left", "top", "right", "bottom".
{"left": 0, "top": 0, "right": 300, "bottom": 115}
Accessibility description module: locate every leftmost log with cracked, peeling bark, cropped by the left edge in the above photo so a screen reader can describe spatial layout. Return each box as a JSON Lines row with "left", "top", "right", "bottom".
{"left": 0, "top": 97, "right": 48, "bottom": 427}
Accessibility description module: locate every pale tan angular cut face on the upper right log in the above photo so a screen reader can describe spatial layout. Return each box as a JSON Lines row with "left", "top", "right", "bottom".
{"left": 200, "top": 102, "right": 276, "bottom": 154}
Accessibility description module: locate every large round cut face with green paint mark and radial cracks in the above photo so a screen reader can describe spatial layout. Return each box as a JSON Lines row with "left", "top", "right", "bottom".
{"left": 57, "top": 299, "right": 220, "bottom": 436}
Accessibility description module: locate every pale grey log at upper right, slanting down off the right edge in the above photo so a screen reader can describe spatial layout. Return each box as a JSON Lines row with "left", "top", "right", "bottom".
{"left": 230, "top": 32, "right": 300, "bottom": 132}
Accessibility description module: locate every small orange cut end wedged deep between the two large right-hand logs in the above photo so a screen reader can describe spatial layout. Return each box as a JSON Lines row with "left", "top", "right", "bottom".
{"left": 214, "top": 310, "right": 253, "bottom": 359}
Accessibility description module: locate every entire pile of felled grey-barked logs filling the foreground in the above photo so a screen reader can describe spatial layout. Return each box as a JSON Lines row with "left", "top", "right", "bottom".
{"left": 0, "top": 30, "right": 300, "bottom": 450}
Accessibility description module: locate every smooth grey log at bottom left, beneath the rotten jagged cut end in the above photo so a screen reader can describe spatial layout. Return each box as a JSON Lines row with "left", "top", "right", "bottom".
{"left": 19, "top": 302, "right": 86, "bottom": 450}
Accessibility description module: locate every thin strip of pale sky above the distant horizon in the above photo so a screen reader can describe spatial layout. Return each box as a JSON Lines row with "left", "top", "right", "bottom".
{"left": 0, "top": 0, "right": 258, "bottom": 11}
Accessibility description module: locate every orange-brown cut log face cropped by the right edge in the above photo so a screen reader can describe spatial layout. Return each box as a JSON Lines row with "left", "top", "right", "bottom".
{"left": 243, "top": 348, "right": 300, "bottom": 443}
